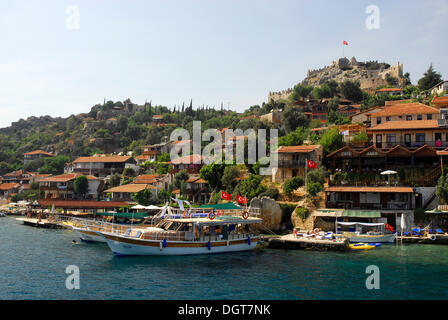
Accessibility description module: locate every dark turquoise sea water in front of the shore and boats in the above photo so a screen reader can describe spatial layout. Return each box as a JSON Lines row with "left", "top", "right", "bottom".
{"left": 0, "top": 217, "right": 448, "bottom": 300}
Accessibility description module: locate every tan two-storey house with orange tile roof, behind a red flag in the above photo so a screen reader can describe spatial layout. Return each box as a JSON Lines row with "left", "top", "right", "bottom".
{"left": 272, "top": 145, "right": 323, "bottom": 183}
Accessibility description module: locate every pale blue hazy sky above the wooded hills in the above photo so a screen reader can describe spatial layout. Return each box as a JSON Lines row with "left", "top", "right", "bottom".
{"left": 0, "top": 0, "right": 448, "bottom": 127}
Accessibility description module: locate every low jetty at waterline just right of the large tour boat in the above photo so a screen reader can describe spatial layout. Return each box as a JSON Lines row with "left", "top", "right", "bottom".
{"left": 268, "top": 234, "right": 349, "bottom": 251}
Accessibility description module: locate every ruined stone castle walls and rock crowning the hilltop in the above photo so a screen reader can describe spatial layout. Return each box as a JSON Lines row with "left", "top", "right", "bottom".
{"left": 268, "top": 57, "right": 406, "bottom": 101}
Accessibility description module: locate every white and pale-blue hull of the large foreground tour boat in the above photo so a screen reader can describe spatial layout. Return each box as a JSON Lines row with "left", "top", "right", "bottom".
{"left": 98, "top": 233, "right": 259, "bottom": 256}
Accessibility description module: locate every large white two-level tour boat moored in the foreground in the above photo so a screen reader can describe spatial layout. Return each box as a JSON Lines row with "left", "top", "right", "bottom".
{"left": 97, "top": 211, "right": 262, "bottom": 256}
